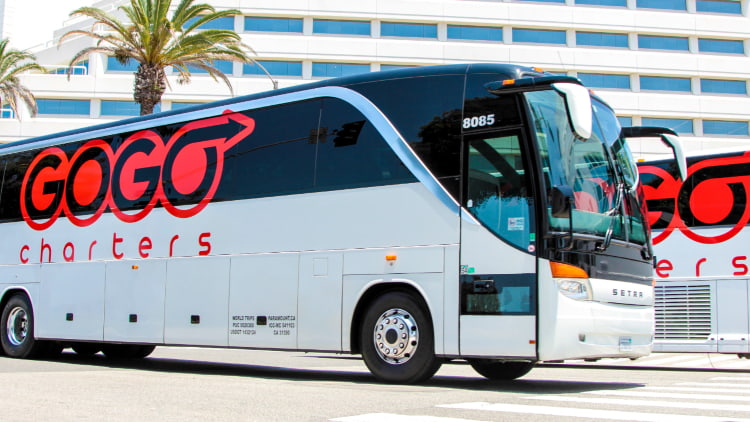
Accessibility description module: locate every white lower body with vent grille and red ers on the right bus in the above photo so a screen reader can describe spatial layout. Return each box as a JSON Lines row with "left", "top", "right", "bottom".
{"left": 654, "top": 227, "right": 750, "bottom": 353}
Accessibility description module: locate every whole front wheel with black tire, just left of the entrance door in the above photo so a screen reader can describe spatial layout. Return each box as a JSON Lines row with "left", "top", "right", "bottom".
{"left": 359, "top": 292, "right": 442, "bottom": 384}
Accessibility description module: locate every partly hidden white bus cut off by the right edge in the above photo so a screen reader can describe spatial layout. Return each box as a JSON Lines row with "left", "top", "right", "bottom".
{"left": 639, "top": 152, "right": 750, "bottom": 358}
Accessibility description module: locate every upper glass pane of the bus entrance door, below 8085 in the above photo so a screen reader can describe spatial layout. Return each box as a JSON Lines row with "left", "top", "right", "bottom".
{"left": 466, "top": 134, "right": 535, "bottom": 251}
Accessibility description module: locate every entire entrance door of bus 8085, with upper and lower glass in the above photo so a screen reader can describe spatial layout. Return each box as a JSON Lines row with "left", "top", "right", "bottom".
{"left": 460, "top": 131, "right": 537, "bottom": 359}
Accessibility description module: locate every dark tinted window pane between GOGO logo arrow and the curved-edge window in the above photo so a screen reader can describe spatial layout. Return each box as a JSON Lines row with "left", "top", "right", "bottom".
{"left": 216, "top": 100, "right": 321, "bottom": 200}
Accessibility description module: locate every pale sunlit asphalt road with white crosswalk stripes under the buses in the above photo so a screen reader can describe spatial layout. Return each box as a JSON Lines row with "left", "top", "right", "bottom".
{"left": 0, "top": 347, "right": 750, "bottom": 422}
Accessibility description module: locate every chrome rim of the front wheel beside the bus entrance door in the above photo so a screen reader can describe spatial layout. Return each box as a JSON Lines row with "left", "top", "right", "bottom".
{"left": 373, "top": 309, "right": 419, "bottom": 365}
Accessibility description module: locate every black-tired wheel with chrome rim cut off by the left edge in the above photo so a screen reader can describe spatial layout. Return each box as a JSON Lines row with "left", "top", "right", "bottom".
{"left": 0, "top": 294, "right": 47, "bottom": 359}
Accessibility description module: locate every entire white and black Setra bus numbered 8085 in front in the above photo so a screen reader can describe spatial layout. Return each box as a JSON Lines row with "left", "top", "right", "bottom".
{"left": 0, "top": 64, "right": 680, "bottom": 382}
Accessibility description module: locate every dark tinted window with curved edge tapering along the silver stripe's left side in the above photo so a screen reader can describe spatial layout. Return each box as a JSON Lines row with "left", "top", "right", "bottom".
{"left": 315, "top": 98, "right": 416, "bottom": 190}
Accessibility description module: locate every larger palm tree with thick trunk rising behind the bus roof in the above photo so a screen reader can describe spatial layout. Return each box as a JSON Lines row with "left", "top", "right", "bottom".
{"left": 60, "top": 0, "right": 252, "bottom": 115}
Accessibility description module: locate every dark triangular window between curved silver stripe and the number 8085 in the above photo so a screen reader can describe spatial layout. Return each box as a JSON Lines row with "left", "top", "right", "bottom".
{"left": 350, "top": 75, "right": 464, "bottom": 199}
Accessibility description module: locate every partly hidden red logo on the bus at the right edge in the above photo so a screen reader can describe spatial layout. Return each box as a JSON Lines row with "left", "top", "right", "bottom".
{"left": 639, "top": 152, "right": 750, "bottom": 244}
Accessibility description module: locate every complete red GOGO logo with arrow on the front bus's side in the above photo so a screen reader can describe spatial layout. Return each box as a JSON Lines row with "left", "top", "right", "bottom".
{"left": 20, "top": 111, "right": 255, "bottom": 230}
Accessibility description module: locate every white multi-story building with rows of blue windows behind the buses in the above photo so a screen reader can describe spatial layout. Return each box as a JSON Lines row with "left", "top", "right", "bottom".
{"left": 0, "top": 0, "right": 750, "bottom": 158}
